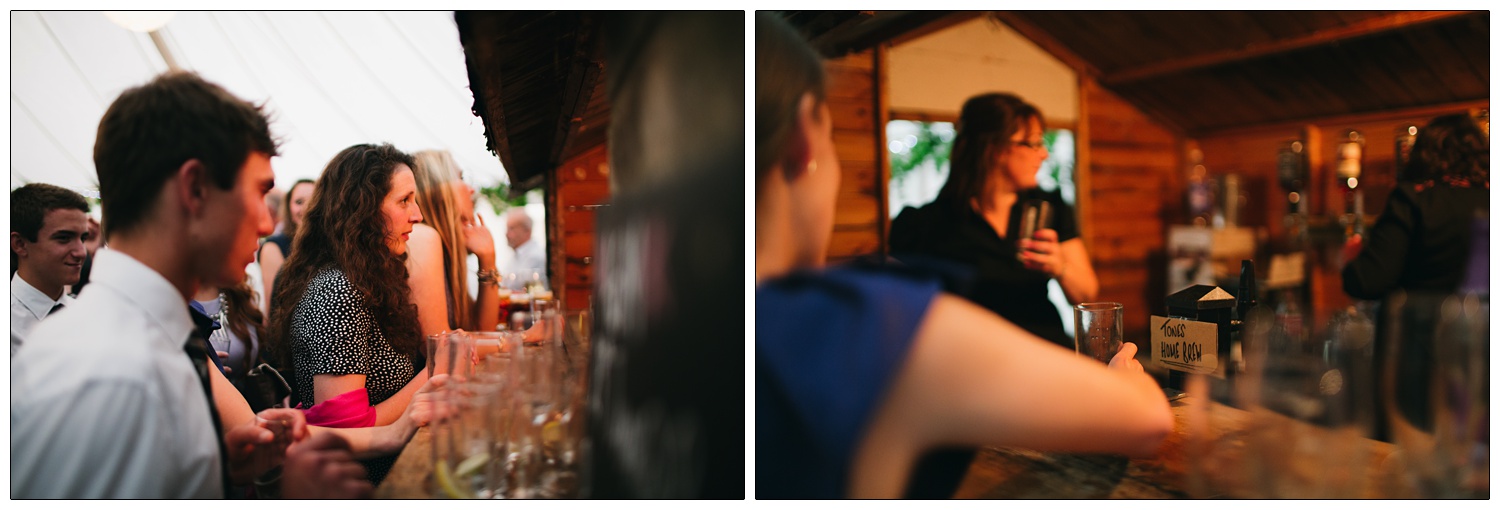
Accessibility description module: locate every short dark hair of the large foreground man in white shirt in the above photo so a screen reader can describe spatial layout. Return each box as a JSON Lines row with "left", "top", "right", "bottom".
{"left": 95, "top": 72, "right": 276, "bottom": 233}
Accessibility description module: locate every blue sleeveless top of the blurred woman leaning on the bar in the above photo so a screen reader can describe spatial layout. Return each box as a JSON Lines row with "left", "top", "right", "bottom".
{"left": 755, "top": 262, "right": 941, "bottom": 500}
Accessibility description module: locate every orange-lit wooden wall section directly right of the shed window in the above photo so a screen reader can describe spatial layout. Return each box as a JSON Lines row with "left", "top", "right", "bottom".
{"left": 1079, "top": 80, "right": 1184, "bottom": 340}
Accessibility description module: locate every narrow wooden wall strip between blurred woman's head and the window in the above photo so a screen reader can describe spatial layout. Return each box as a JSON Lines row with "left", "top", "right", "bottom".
{"left": 824, "top": 50, "right": 888, "bottom": 261}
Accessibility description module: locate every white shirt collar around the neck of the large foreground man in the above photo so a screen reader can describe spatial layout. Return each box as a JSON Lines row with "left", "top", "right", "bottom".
{"left": 89, "top": 248, "right": 194, "bottom": 348}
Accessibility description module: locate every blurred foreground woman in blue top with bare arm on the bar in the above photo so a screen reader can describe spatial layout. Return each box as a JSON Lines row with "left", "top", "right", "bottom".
{"left": 755, "top": 14, "right": 1173, "bottom": 498}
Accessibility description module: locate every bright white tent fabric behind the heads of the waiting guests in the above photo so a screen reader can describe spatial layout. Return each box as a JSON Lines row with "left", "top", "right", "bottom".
{"left": 11, "top": 11, "right": 509, "bottom": 197}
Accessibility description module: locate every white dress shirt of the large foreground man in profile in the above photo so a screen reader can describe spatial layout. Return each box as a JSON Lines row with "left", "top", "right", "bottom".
{"left": 11, "top": 249, "right": 224, "bottom": 500}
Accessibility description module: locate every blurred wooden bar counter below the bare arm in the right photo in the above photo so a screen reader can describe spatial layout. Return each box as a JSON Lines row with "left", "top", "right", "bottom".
{"left": 954, "top": 396, "right": 1392, "bottom": 500}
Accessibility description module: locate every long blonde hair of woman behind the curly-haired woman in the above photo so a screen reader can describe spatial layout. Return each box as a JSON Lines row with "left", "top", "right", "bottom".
{"left": 411, "top": 150, "right": 479, "bottom": 330}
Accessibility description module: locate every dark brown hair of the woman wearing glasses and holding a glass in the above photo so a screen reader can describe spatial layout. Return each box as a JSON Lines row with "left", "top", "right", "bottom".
{"left": 938, "top": 93, "right": 1041, "bottom": 207}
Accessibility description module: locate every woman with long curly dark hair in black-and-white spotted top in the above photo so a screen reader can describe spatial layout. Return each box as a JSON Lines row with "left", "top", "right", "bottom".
{"left": 269, "top": 144, "right": 426, "bottom": 483}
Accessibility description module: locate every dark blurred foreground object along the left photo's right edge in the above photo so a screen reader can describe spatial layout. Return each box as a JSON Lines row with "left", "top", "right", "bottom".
{"left": 588, "top": 11, "right": 746, "bottom": 500}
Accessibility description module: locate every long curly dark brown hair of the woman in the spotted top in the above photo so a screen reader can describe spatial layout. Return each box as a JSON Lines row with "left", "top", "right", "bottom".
{"left": 267, "top": 144, "right": 423, "bottom": 369}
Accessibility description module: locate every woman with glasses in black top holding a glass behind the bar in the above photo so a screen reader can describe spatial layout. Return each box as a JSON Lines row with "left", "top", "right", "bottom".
{"left": 891, "top": 93, "right": 1100, "bottom": 350}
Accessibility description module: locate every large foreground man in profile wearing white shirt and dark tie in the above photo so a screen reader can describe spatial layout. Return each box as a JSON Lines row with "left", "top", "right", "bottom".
{"left": 11, "top": 72, "right": 371, "bottom": 500}
